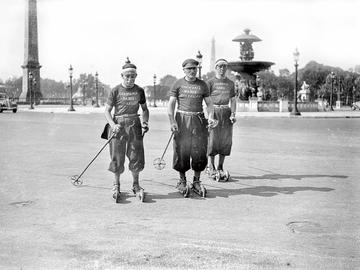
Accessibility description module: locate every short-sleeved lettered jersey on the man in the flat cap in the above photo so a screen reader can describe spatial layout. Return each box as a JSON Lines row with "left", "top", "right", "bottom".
{"left": 170, "top": 78, "right": 209, "bottom": 112}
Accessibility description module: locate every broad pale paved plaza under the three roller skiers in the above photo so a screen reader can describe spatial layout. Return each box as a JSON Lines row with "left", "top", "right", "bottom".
{"left": 0, "top": 106, "right": 360, "bottom": 270}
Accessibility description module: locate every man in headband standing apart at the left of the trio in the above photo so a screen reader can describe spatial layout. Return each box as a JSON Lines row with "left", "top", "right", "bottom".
{"left": 105, "top": 60, "right": 149, "bottom": 202}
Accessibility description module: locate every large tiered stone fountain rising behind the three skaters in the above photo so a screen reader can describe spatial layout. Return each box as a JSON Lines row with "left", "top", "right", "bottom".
{"left": 229, "top": 29, "right": 274, "bottom": 100}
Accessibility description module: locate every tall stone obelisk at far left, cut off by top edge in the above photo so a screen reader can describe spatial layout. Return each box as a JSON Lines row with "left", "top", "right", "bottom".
{"left": 20, "top": 0, "right": 42, "bottom": 104}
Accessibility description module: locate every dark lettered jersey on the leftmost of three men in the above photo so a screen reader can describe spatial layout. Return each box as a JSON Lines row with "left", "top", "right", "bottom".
{"left": 106, "top": 84, "right": 146, "bottom": 115}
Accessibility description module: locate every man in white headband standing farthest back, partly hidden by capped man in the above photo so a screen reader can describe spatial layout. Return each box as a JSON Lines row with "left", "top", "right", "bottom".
{"left": 207, "top": 59, "right": 236, "bottom": 180}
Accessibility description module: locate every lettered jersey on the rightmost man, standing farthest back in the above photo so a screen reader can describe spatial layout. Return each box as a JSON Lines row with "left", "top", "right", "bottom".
{"left": 207, "top": 77, "right": 235, "bottom": 105}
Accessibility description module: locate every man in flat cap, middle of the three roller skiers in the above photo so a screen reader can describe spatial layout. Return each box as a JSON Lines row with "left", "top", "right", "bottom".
{"left": 168, "top": 59, "right": 213, "bottom": 196}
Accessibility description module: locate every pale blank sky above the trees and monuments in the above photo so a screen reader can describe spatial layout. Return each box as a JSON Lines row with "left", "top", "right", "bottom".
{"left": 0, "top": 0, "right": 360, "bottom": 87}
